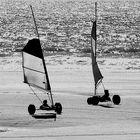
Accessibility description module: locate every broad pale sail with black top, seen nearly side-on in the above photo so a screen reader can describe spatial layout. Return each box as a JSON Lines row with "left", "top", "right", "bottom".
{"left": 22, "top": 39, "right": 51, "bottom": 91}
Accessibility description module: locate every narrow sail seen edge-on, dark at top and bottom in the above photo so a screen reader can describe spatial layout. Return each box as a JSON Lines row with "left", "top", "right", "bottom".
{"left": 91, "top": 21, "right": 103, "bottom": 89}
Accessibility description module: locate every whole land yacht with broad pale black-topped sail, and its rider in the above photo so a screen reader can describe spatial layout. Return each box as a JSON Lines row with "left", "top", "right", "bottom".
{"left": 22, "top": 5, "right": 62, "bottom": 118}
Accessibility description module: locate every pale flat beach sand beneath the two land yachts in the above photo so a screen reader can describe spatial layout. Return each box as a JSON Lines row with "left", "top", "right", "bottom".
{"left": 0, "top": 65, "right": 140, "bottom": 140}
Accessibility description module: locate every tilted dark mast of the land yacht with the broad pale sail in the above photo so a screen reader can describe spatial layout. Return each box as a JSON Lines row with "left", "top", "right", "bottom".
{"left": 30, "top": 5, "right": 54, "bottom": 105}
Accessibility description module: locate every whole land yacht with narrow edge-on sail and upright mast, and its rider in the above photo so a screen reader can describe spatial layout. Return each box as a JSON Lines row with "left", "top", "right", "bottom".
{"left": 87, "top": 2, "right": 121, "bottom": 105}
